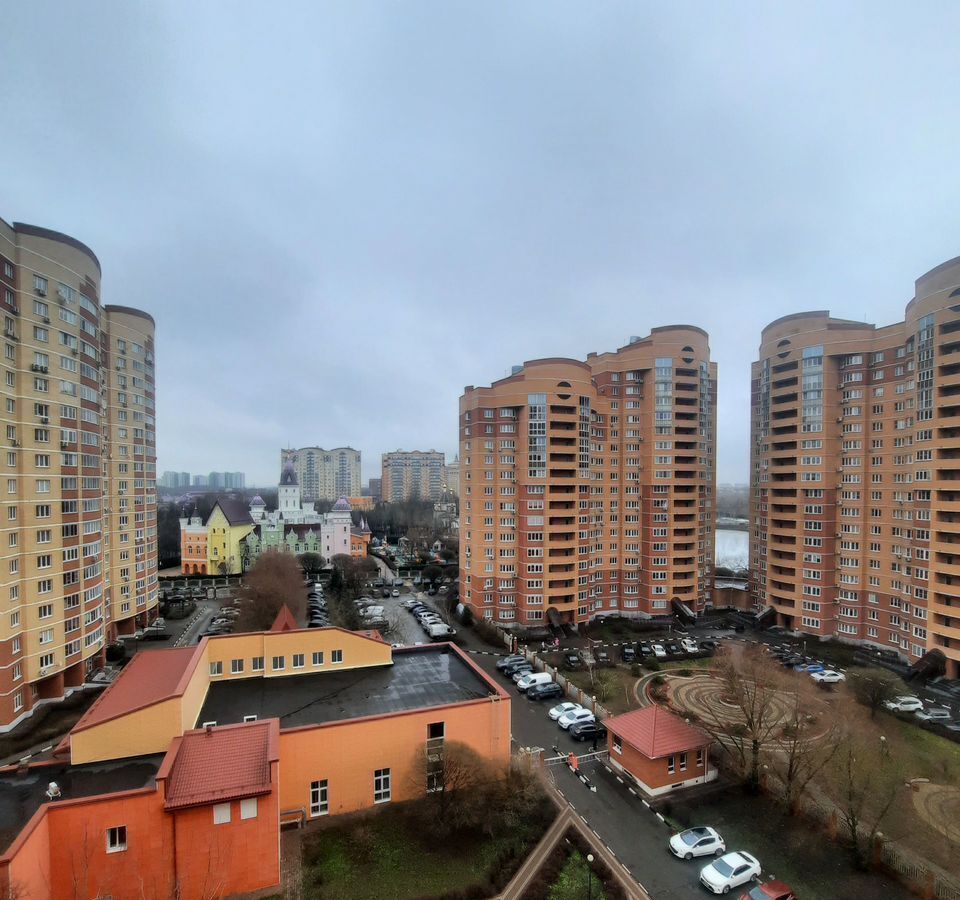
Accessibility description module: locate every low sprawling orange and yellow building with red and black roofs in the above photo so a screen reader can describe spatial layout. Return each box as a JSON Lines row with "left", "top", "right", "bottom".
{"left": 0, "top": 618, "right": 510, "bottom": 900}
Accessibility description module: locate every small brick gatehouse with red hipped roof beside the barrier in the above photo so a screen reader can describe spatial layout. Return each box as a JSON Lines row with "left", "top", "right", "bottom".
{"left": 603, "top": 703, "right": 717, "bottom": 796}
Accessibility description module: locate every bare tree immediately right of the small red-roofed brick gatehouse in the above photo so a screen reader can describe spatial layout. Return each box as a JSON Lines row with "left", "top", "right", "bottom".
{"left": 699, "top": 646, "right": 786, "bottom": 792}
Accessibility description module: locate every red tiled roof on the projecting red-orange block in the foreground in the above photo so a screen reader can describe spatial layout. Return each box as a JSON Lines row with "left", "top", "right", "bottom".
{"left": 157, "top": 719, "right": 280, "bottom": 809}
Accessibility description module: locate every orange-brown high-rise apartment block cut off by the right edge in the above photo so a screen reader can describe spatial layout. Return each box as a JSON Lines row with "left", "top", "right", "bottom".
{"left": 750, "top": 257, "right": 960, "bottom": 678}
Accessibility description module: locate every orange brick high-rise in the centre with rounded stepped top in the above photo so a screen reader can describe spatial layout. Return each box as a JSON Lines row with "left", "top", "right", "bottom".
{"left": 460, "top": 325, "right": 717, "bottom": 625}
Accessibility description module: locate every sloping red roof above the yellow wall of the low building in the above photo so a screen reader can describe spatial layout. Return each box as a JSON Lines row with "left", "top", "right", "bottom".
{"left": 71, "top": 647, "right": 197, "bottom": 731}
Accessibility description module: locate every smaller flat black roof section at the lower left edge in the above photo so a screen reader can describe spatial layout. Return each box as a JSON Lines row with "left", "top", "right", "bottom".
{"left": 0, "top": 753, "right": 164, "bottom": 851}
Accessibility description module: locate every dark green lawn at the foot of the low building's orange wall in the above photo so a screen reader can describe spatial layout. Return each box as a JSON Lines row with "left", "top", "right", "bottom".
{"left": 303, "top": 807, "right": 543, "bottom": 900}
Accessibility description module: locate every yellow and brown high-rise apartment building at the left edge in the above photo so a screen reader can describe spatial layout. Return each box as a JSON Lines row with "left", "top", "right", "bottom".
{"left": 0, "top": 220, "right": 157, "bottom": 731}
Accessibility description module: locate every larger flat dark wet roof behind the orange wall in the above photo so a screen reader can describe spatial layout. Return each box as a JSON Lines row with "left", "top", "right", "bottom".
{"left": 196, "top": 645, "right": 496, "bottom": 728}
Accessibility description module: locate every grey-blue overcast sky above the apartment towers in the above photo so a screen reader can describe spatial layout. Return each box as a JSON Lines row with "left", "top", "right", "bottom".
{"left": 0, "top": 0, "right": 960, "bottom": 484}
